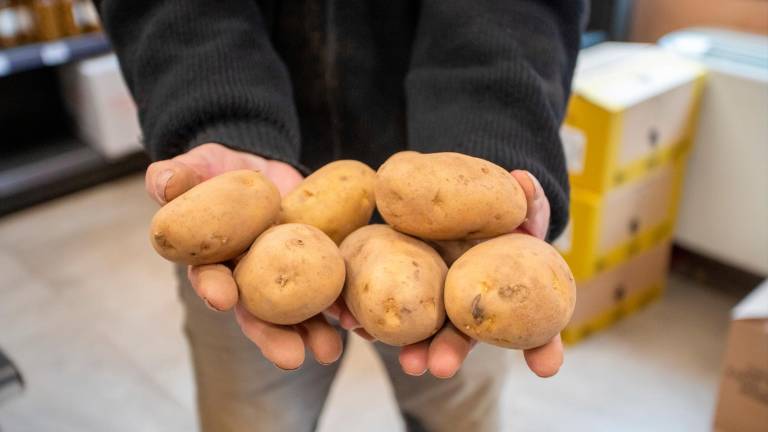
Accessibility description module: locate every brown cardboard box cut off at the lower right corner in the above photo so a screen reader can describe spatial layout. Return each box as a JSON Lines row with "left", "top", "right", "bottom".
{"left": 714, "top": 280, "right": 768, "bottom": 432}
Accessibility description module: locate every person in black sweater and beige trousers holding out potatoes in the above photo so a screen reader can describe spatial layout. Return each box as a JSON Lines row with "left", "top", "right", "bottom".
{"left": 97, "top": 0, "right": 587, "bottom": 432}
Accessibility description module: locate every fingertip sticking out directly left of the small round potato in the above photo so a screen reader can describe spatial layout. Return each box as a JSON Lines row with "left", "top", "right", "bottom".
{"left": 187, "top": 264, "right": 238, "bottom": 311}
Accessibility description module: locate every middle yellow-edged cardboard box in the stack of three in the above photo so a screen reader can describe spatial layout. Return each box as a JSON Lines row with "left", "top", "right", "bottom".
{"left": 554, "top": 155, "right": 685, "bottom": 281}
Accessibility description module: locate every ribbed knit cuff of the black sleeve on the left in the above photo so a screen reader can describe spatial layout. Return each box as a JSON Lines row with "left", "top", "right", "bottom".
{"left": 187, "top": 120, "right": 309, "bottom": 175}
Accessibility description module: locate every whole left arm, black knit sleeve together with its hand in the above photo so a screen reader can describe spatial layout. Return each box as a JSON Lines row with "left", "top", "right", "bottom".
{"left": 98, "top": 0, "right": 342, "bottom": 369}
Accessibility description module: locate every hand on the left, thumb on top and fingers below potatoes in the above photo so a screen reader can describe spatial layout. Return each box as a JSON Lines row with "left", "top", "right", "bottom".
{"left": 145, "top": 144, "right": 342, "bottom": 369}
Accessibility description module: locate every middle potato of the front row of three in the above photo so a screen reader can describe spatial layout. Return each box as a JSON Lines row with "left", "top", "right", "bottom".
{"left": 341, "top": 225, "right": 448, "bottom": 346}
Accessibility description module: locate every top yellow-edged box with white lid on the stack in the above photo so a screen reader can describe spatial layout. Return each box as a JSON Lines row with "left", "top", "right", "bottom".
{"left": 561, "top": 43, "right": 704, "bottom": 193}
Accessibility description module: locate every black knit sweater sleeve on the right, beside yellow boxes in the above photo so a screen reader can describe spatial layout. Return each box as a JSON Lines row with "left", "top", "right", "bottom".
{"left": 406, "top": 0, "right": 585, "bottom": 240}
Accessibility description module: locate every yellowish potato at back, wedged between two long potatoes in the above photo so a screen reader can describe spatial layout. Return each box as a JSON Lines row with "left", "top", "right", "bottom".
{"left": 281, "top": 160, "right": 376, "bottom": 244}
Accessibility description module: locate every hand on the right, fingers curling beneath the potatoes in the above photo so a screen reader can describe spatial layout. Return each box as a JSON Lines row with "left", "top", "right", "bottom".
{"left": 337, "top": 170, "right": 563, "bottom": 378}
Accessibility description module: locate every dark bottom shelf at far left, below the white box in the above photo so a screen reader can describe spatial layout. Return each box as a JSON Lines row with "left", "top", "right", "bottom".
{"left": 0, "top": 139, "right": 148, "bottom": 216}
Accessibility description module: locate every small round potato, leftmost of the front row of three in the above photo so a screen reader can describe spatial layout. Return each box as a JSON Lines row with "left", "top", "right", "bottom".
{"left": 235, "top": 224, "right": 344, "bottom": 324}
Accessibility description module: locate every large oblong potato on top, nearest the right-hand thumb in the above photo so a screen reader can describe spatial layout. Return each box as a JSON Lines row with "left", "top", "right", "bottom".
{"left": 375, "top": 153, "right": 527, "bottom": 240}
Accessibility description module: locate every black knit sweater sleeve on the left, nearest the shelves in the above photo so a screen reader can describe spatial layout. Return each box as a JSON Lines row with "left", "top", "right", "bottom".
{"left": 97, "top": 0, "right": 300, "bottom": 165}
